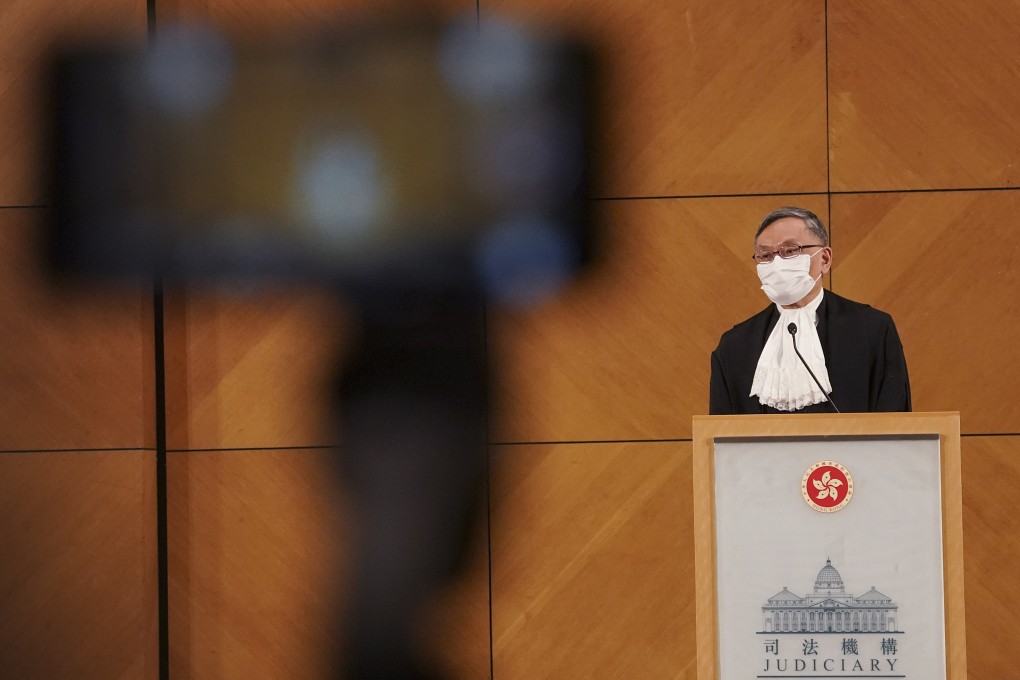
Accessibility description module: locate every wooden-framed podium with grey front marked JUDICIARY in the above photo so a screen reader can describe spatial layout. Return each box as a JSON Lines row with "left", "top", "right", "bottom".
{"left": 694, "top": 413, "right": 967, "bottom": 680}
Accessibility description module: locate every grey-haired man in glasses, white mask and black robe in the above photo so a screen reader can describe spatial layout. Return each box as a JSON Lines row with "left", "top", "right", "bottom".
{"left": 709, "top": 208, "right": 911, "bottom": 415}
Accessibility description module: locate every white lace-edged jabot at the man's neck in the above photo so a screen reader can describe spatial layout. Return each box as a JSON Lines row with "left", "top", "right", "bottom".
{"left": 751, "top": 290, "right": 832, "bottom": 411}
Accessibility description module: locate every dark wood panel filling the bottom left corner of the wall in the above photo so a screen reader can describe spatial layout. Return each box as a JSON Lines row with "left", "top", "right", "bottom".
{"left": 0, "top": 452, "right": 157, "bottom": 680}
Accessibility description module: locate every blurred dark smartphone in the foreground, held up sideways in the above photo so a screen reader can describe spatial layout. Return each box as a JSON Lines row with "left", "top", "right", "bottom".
{"left": 49, "top": 15, "right": 595, "bottom": 297}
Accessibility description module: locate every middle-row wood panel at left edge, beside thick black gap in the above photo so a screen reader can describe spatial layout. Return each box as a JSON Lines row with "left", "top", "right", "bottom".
{"left": 0, "top": 209, "right": 155, "bottom": 452}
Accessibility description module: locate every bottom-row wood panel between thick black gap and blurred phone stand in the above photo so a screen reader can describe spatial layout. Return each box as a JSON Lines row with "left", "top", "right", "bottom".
{"left": 167, "top": 451, "right": 346, "bottom": 680}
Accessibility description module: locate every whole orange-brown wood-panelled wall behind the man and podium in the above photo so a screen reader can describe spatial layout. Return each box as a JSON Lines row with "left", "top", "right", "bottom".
{"left": 0, "top": 0, "right": 999, "bottom": 680}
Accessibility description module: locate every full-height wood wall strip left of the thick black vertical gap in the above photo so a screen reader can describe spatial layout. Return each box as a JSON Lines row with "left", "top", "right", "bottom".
{"left": 0, "top": 6, "right": 158, "bottom": 680}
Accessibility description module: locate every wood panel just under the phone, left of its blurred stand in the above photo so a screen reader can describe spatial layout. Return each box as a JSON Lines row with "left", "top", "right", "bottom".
{"left": 165, "top": 290, "right": 346, "bottom": 451}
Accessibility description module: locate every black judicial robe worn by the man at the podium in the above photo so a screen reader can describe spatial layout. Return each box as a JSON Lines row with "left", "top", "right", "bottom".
{"left": 709, "top": 291, "right": 911, "bottom": 415}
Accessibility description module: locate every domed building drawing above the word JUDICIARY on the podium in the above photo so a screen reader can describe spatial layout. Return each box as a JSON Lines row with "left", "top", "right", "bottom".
{"left": 762, "top": 560, "right": 903, "bottom": 633}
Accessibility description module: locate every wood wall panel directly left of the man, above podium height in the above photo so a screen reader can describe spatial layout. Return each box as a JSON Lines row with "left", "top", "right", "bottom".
{"left": 490, "top": 196, "right": 827, "bottom": 441}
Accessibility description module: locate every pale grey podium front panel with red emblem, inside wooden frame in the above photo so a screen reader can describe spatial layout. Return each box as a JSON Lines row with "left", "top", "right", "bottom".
{"left": 714, "top": 435, "right": 946, "bottom": 680}
